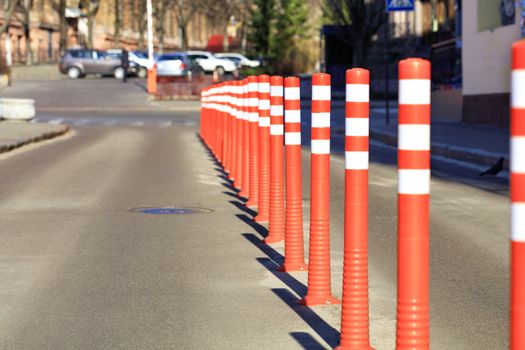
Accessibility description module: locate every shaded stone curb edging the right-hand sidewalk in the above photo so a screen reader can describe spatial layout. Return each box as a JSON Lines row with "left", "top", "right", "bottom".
{"left": 370, "top": 129, "right": 509, "bottom": 170}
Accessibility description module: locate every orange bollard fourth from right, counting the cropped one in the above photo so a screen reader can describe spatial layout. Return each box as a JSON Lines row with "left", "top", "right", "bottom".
{"left": 302, "top": 73, "right": 340, "bottom": 306}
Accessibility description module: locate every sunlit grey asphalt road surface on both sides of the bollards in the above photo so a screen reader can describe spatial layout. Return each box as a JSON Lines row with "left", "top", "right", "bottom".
{"left": 0, "top": 79, "right": 509, "bottom": 350}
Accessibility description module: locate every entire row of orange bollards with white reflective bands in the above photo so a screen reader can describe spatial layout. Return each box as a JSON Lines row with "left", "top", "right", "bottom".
{"left": 200, "top": 41, "right": 525, "bottom": 349}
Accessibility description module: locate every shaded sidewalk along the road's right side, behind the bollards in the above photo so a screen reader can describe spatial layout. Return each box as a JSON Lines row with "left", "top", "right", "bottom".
{"left": 370, "top": 106, "right": 509, "bottom": 169}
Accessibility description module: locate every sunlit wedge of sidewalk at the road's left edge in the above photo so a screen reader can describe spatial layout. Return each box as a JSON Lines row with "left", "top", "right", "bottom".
{"left": 0, "top": 121, "right": 69, "bottom": 153}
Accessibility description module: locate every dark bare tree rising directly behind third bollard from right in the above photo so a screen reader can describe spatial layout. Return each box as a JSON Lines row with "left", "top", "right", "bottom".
{"left": 325, "top": 0, "right": 385, "bottom": 67}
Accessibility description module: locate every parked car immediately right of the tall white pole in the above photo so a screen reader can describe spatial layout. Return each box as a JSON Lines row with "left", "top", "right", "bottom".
{"left": 157, "top": 52, "right": 202, "bottom": 79}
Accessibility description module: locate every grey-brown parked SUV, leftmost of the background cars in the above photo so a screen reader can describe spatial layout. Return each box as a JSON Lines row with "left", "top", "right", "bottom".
{"left": 58, "top": 49, "right": 124, "bottom": 79}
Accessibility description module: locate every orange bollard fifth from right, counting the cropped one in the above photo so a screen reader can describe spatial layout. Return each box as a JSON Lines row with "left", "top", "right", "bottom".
{"left": 281, "top": 77, "right": 307, "bottom": 271}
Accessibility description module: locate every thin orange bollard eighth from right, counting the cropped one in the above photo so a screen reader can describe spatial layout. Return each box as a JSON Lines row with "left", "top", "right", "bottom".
{"left": 246, "top": 75, "right": 259, "bottom": 207}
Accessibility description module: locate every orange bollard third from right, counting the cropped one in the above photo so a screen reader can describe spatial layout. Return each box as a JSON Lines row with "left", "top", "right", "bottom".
{"left": 337, "top": 68, "right": 372, "bottom": 350}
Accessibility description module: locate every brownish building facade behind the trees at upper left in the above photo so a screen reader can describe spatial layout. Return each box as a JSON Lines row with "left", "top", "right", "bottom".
{"left": 0, "top": 0, "right": 220, "bottom": 64}
